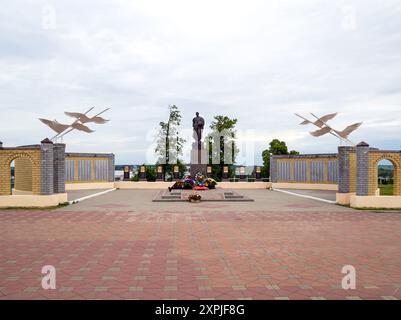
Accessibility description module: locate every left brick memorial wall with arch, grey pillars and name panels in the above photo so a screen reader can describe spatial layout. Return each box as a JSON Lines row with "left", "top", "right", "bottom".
{"left": 0, "top": 139, "right": 114, "bottom": 195}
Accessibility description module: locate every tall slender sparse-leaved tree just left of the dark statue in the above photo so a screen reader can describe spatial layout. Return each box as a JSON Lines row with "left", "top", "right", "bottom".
{"left": 155, "top": 105, "right": 185, "bottom": 180}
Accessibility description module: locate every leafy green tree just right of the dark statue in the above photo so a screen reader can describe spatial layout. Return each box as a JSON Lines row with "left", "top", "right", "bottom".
{"left": 205, "top": 115, "right": 239, "bottom": 181}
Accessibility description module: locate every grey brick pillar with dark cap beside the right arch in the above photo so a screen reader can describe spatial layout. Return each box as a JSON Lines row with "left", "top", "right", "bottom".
{"left": 356, "top": 142, "right": 369, "bottom": 196}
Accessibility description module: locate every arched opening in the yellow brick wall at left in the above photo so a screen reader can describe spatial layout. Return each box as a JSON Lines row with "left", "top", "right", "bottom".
{"left": 10, "top": 157, "right": 32, "bottom": 195}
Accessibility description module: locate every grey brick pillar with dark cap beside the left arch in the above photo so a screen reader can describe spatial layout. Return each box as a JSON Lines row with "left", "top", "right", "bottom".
{"left": 40, "top": 138, "right": 54, "bottom": 195}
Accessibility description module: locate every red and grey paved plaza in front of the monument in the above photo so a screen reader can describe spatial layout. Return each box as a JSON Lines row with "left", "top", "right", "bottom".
{"left": 0, "top": 190, "right": 401, "bottom": 299}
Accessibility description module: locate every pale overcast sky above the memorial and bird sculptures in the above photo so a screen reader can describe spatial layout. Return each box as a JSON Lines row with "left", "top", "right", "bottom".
{"left": 0, "top": 0, "right": 401, "bottom": 164}
